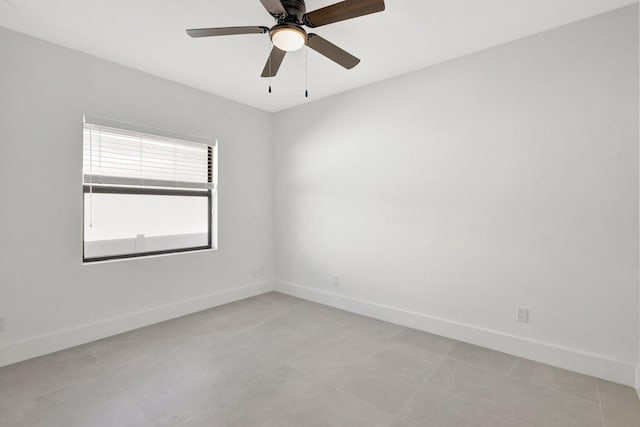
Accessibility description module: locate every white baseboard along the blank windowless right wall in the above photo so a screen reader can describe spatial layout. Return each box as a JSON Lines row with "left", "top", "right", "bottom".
{"left": 275, "top": 281, "right": 640, "bottom": 388}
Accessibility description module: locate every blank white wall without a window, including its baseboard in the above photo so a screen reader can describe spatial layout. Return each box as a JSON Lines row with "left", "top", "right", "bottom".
{"left": 274, "top": 5, "right": 639, "bottom": 384}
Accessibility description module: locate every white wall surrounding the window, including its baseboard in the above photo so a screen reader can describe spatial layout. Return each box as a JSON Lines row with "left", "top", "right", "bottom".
{"left": 0, "top": 28, "right": 273, "bottom": 366}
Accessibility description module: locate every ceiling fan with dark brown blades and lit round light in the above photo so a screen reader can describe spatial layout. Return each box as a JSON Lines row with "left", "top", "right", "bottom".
{"left": 187, "top": 0, "right": 385, "bottom": 77}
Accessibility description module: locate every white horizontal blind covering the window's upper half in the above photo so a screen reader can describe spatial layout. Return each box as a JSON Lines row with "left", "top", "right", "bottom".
{"left": 83, "top": 123, "right": 213, "bottom": 189}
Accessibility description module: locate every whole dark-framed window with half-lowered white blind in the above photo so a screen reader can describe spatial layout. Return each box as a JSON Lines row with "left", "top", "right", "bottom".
{"left": 83, "top": 118, "right": 217, "bottom": 262}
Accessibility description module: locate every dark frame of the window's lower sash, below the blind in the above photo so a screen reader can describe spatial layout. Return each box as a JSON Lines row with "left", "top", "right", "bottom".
{"left": 82, "top": 184, "right": 213, "bottom": 263}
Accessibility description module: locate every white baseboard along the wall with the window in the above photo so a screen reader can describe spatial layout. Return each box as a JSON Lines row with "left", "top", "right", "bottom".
{"left": 0, "top": 282, "right": 274, "bottom": 367}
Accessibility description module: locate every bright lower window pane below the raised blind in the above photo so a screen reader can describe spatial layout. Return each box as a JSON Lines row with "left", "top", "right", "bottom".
{"left": 84, "top": 193, "right": 209, "bottom": 258}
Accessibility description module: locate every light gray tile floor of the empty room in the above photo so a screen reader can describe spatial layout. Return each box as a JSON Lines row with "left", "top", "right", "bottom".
{"left": 0, "top": 293, "right": 640, "bottom": 427}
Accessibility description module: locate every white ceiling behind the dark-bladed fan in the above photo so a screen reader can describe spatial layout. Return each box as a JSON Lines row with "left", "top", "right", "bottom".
{"left": 0, "top": 0, "right": 637, "bottom": 111}
